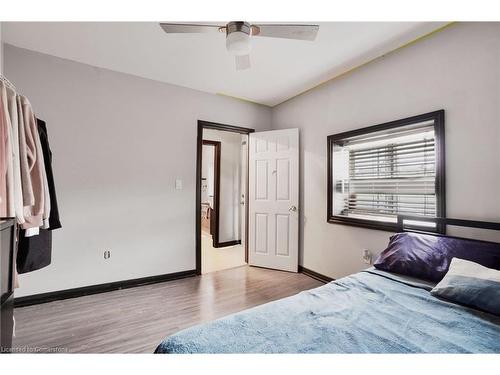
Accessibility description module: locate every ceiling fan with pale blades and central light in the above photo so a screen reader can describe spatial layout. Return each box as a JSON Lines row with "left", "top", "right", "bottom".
{"left": 160, "top": 21, "right": 319, "bottom": 70}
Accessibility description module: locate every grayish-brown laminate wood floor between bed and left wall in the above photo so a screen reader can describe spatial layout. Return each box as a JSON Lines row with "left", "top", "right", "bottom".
{"left": 13, "top": 266, "right": 322, "bottom": 353}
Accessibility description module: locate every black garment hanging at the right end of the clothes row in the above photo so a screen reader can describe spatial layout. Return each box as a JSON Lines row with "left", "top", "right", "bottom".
{"left": 16, "top": 119, "right": 61, "bottom": 273}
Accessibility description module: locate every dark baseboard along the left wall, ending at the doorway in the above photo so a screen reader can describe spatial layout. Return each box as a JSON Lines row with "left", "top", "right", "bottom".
{"left": 14, "top": 270, "right": 196, "bottom": 307}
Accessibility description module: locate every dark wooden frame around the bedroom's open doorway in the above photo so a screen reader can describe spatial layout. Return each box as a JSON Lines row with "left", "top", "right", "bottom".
{"left": 195, "top": 120, "right": 255, "bottom": 275}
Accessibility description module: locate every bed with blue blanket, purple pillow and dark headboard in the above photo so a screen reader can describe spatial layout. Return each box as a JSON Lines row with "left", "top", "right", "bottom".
{"left": 155, "top": 215, "right": 500, "bottom": 354}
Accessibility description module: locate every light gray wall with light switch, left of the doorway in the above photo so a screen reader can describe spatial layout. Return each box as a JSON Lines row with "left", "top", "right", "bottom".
{"left": 4, "top": 45, "right": 271, "bottom": 296}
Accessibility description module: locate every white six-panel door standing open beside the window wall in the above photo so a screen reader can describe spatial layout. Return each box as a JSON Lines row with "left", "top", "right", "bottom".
{"left": 248, "top": 129, "right": 299, "bottom": 272}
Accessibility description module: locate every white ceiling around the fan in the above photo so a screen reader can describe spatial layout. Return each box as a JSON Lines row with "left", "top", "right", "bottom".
{"left": 2, "top": 22, "right": 446, "bottom": 106}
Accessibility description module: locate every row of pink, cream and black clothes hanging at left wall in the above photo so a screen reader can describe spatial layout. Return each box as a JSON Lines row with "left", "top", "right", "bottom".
{"left": 0, "top": 77, "right": 61, "bottom": 276}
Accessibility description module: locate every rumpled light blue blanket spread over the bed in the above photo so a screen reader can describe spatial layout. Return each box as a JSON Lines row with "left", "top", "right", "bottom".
{"left": 156, "top": 271, "right": 500, "bottom": 353}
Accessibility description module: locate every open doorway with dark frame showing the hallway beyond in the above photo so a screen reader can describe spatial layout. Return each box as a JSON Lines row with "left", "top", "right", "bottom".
{"left": 196, "top": 121, "right": 253, "bottom": 274}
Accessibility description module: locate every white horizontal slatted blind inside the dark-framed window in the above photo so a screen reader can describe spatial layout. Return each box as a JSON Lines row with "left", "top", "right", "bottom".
{"left": 337, "top": 127, "right": 437, "bottom": 221}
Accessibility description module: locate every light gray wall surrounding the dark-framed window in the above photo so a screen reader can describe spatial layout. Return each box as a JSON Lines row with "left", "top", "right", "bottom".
{"left": 273, "top": 23, "right": 500, "bottom": 278}
